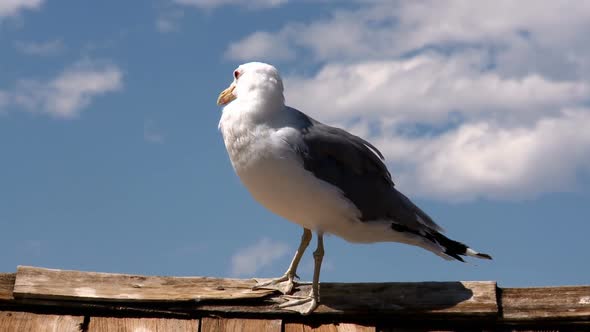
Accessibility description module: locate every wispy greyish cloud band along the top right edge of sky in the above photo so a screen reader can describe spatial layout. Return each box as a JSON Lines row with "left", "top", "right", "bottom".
{"left": 228, "top": 0, "right": 590, "bottom": 68}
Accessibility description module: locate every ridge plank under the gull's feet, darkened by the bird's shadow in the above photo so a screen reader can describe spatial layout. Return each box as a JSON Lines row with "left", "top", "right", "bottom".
{"left": 192, "top": 281, "right": 498, "bottom": 317}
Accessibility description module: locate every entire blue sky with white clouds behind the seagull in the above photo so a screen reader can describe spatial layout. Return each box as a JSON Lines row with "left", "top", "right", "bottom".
{"left": 0, "top": 0, "right": 590, "bottom": 286}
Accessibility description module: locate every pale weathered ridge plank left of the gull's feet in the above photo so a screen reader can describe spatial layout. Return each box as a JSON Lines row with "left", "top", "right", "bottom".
{"left": 13, "top": 266, "right": 274, "bottom": 302}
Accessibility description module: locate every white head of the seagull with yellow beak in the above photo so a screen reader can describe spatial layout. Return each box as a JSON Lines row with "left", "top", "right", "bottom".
{"left": 217, "top": 62, "right": 285, "bottom": 105}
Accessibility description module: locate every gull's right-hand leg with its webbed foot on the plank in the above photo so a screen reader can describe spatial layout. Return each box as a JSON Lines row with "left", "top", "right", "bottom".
{"left": 279, "top": 232, "right": 324, "bottom": 315}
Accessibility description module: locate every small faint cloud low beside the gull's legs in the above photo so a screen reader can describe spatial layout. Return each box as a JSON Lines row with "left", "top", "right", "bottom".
{"left": 231, "top": 238, "right": 288, "bottom": 276}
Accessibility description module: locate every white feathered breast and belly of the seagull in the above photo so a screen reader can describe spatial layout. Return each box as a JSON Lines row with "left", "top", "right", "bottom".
{"left": 220, "top": 109, "right": 360, "bottom": 235}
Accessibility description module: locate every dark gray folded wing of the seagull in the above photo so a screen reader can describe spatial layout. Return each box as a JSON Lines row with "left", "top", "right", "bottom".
{"left": 291, "top": 109, "right": 442, "bottom": 233}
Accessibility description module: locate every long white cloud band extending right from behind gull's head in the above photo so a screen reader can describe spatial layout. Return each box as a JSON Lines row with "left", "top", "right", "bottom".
{"left": 285, "top": 53, "right": 590, "bottom": 123}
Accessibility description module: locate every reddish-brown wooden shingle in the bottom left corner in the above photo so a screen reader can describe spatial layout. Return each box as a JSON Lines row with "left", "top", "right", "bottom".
{"left": 0, "top": 311, "right": 84, "bottom": 332}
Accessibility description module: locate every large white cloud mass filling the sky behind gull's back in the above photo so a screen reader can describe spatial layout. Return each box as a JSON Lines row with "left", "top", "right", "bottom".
{"left": 226, "top": 0, "right": 590, "bottom": 200}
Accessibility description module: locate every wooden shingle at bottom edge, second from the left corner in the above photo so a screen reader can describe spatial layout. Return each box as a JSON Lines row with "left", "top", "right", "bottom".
{"left": 88, "top": 317, "right": 199, "bottom": 332}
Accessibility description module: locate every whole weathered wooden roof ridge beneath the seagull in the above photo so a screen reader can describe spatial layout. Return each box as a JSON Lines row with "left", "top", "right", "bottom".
{"left": 0, "top": 266, "right": 590, "bottom": 331}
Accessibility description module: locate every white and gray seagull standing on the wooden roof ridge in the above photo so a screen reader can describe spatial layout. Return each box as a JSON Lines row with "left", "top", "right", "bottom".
{"left": 217, "top": 62, "right": 491, "bottom": 315}
